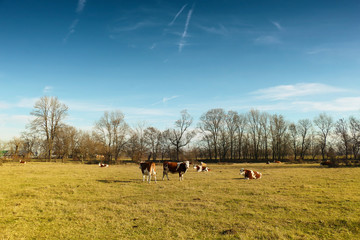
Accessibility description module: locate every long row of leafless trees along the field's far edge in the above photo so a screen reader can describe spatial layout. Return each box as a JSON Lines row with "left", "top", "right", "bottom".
{"left": 0, "top": 96, "right": 360, "bottom": 163}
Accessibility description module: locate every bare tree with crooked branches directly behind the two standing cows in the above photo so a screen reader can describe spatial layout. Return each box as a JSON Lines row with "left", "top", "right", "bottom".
{"left": 167, "top": 110, "right": 195, "bottom": 161}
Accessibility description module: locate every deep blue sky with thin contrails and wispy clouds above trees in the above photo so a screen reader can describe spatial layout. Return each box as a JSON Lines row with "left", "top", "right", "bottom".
{"left": 0, "top": 0, "right": 360, "bottom": 140}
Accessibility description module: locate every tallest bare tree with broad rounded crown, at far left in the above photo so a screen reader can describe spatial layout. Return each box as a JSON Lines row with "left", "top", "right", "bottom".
{"left": 30, "top": 96, "right": 68, "bottom": 161}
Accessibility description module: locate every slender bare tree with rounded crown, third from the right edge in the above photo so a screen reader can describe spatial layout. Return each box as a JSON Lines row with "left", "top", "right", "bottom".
{"left": 314, "top": 113, "right": 333, "bottom": 160}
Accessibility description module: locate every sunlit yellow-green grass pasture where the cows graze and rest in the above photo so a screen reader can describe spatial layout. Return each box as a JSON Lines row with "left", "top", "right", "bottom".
{"left": 0, "top": 163, "right": 360, "bottom": 239}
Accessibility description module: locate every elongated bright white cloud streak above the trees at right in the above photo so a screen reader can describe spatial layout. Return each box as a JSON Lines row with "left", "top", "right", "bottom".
{"left": 252, "top": 83, "right": 348, "bottom": 100}
